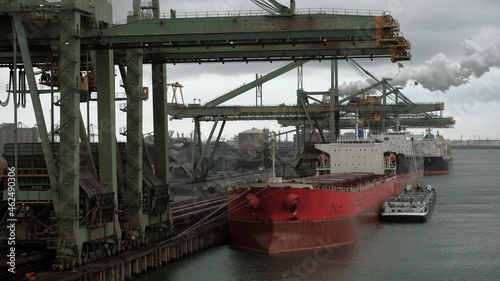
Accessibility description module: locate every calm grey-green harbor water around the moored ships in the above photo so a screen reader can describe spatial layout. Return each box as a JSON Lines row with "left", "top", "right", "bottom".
{"left": 138, "top": 149, "right": 500, "bottom": 281}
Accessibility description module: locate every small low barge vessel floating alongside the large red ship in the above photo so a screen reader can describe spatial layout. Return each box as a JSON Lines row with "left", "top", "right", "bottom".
{"left": 380, "top": 184, "right": 437, "bottom": 223}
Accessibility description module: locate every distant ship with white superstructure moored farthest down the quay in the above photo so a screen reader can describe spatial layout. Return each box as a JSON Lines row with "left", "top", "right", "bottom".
{"left": 416, "top": 129, "right": 453, "bottom": 175}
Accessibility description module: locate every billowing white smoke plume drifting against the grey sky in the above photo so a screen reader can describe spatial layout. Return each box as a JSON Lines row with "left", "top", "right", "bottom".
{"left": 391, "top": 39, "right": 500, "bottom": 92}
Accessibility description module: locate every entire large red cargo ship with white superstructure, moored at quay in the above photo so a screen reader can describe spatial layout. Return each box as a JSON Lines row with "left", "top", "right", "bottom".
{"left": 228, "top": 133, "right": 423, "bottom": 254}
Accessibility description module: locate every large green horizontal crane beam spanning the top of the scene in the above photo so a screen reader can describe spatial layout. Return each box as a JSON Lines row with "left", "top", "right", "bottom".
{"left": 0, "top": 4, "right": 410, "bottom": 64}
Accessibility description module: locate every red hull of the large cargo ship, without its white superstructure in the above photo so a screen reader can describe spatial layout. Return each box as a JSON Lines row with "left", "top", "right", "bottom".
{"left": 228, "top": 174, "right": 415, "bottom": 254}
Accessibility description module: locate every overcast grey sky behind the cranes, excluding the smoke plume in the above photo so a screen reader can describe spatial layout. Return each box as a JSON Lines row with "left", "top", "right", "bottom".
{"left": 0, "top": 0, "right": 500, "bottom": 139}
